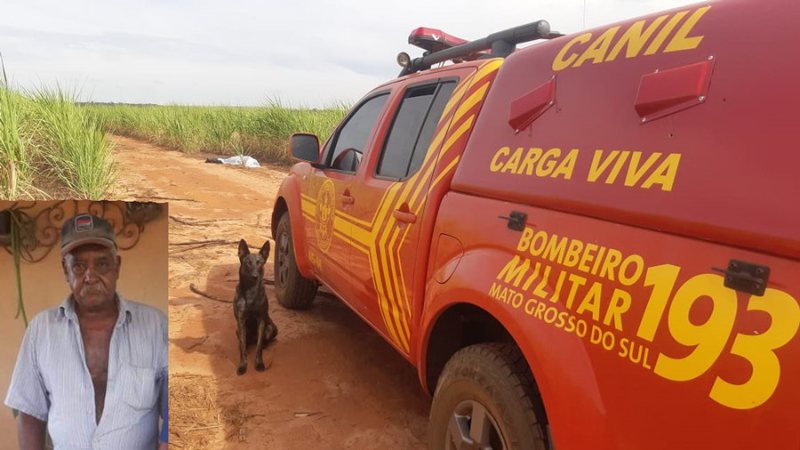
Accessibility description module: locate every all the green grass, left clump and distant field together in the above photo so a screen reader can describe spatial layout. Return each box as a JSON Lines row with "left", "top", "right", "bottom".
{"left": 0, "top": 70, "right": 348, "bottom": 199}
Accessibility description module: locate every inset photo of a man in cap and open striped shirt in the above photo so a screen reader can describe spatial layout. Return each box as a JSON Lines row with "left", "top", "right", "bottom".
{"left": 0, "top": 200, "right": 169, "bottom": 449}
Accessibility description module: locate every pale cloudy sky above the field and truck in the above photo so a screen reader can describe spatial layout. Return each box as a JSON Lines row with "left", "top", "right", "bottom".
{"left": 0, "top": 0, "right": 695, "bottom": 107}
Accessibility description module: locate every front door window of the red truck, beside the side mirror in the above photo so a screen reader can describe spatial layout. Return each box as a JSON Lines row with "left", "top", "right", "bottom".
{"left": 327, "top": 93, "right": 389, "bottom": 172}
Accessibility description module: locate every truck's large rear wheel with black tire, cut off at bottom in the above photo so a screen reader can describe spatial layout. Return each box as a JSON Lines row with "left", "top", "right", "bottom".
{"left": 428, "top": 343, "right": 552, "bottom": 450}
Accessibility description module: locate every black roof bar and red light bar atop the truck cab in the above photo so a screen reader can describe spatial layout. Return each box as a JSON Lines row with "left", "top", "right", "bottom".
{"left": 397, "top": 20, "right": 562, "bottom": 77}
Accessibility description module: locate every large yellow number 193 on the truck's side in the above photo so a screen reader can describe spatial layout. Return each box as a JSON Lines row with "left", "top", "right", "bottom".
{"left": 637, "top": 264, "right": 800, "bottom": 409}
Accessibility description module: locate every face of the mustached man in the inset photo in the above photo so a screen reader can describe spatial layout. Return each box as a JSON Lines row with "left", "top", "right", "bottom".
{"left": 61, "top": 244, "right": 121, "bottom": 310}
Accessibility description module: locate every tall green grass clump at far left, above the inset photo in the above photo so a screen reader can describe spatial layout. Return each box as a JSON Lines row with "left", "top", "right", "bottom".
{"left": 0, "top": 78, "right": 114, "bottom": 199}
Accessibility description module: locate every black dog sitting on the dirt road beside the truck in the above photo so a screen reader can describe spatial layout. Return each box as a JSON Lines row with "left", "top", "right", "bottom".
{"left": 233, "top": 239, "right": 278, "bottom": 375}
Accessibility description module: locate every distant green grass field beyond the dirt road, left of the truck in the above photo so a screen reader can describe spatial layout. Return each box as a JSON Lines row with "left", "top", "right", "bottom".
{"left": 84, "top": 100, "right": 348, "bottom": 163}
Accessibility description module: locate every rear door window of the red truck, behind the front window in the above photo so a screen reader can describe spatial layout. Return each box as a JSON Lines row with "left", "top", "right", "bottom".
{"left": 377, "top": 82, "right": 456, "bottom": 179}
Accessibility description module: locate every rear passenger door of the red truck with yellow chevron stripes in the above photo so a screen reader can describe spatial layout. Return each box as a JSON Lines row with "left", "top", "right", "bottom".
{"left": 342, "top": 79, "right": 466, "bottom": 354}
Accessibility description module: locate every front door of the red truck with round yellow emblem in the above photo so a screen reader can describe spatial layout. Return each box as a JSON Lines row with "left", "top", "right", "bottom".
{"left": 303, "top": 92, "right": 389, "bottom": 299}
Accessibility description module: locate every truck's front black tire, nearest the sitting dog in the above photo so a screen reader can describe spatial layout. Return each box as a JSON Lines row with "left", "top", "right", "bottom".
{"left": 275, "top": 212, "right": 317, "bottom": 309}
